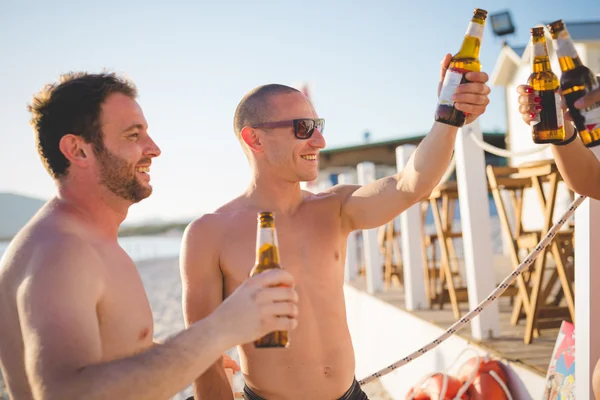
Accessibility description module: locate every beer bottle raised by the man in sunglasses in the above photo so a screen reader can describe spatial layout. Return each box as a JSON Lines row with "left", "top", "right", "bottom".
{"left": 435, "top": 8, "right": 487, "bottom": 127}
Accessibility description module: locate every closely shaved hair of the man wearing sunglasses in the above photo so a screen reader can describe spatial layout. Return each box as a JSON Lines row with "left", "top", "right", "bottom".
{"left": 233, "top": 83, "right": 300, "bottom": 151}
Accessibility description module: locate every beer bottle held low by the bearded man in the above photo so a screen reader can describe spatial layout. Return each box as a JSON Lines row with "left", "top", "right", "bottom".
{"left": 250, "top": 211, "right": 290, "bottom": 348}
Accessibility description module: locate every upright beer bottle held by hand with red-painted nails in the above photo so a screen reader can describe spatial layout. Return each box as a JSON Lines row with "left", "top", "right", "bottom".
{"left": 527, "top": 26, "right": 565, "bottom": 143}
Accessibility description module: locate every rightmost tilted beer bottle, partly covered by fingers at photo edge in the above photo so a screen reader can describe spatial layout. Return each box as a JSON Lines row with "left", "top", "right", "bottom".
{"left": 548, "top": 19, "right": 600, "bottom": 147}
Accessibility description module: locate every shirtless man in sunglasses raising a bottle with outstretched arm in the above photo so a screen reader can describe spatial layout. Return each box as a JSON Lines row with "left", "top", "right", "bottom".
{"left": 181, "top": 55, "right": 490, "bottom": 400}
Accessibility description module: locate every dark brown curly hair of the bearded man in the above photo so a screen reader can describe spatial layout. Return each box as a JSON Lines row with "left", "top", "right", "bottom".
{"left": 27, "top": 72, "right": 137, "bottom": 179}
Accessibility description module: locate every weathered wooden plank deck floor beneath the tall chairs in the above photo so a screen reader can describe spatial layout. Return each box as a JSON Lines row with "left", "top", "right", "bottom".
{"left": 350, "top": 277, "right": 558, "bottom": 376}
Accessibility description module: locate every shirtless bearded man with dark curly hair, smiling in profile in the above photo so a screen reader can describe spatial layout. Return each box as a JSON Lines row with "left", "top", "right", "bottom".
{"left": 0, "top": 73, "right": 297, "bottom": 400}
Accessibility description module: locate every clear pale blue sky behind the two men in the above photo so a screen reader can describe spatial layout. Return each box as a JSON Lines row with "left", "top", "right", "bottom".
{"left": 0, "top": 0, "right": 600, "bottom": 222}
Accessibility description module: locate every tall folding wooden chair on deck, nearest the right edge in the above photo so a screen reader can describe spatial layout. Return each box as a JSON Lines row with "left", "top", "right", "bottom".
{"left": 486, "top": 160, "right": 575, "bottom": 344}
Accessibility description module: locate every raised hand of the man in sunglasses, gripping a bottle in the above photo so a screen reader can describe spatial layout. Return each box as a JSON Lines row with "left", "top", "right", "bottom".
{"left": 438, "top": 54, "right": 491, "bottom": 124}
